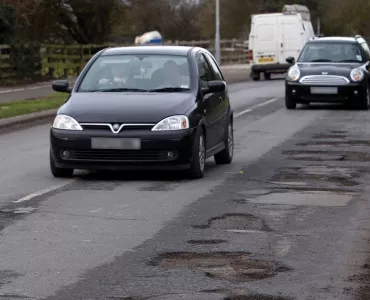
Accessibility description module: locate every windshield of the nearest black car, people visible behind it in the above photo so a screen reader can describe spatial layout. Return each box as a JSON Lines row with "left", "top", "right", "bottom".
{"left": 78, "top": 54, "right": 190, "bottom": 93}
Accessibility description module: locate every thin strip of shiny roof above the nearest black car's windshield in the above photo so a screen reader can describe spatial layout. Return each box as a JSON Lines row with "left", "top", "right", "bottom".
{"left": 101, "top": 45, "right": 194, "bottom": 56}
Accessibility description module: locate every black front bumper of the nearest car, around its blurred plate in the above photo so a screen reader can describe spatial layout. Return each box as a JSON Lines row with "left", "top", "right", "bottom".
{"left": 50, "top": 128, "right": 197, "bottom": 170}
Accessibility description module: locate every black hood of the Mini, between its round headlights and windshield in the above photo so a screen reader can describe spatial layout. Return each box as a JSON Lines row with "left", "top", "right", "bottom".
{"left": 297, "top": 63, "right": 362, "bottom": 77}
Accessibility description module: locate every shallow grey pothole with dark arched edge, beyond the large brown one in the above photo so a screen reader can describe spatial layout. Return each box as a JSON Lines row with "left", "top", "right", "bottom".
{"left": 193, "top": 213, "right": 272, "bottom": 231}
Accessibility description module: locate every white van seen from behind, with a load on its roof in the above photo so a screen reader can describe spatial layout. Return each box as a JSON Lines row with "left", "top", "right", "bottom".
{"left": 248, "top": 5, "right": 315, "bottom": 80}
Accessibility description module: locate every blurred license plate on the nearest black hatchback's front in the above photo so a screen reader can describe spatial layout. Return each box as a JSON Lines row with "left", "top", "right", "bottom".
{"left": 91, "top": 138, "right": 141, "bottom": 150}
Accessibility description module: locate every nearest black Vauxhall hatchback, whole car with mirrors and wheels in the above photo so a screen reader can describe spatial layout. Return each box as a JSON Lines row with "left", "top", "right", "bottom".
{"left": 50, "top": 46, "right": 234, "bottom": 178}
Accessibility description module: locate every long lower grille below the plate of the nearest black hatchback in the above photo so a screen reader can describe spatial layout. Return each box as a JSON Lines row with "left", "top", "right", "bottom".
{"left": 61, "top": 149, "right": 174, "bottom": 162}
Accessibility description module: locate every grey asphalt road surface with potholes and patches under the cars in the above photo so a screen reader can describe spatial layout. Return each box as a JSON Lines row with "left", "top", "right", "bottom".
{"left": 0, "top": 76, "right": 370, "bottom": 300}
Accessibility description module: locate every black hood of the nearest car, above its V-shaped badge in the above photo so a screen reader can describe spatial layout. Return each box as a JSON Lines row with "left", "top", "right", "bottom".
{"left": 58, "top": 92, "right": 194, "bottom": 123}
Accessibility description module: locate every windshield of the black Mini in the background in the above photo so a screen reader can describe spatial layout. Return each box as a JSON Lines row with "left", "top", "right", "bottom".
{"left": 298, "top": 42, "right": 365, "bottom": 63}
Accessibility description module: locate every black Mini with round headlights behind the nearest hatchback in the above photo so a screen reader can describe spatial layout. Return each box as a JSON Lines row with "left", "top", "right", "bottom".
{"left": 285, "top": 36, "right": 370, "bottom": 110}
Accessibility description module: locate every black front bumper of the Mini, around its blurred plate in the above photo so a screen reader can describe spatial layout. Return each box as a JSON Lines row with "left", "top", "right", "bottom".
{"left": 285, "top": 81, "right": 367, "bottom": 103}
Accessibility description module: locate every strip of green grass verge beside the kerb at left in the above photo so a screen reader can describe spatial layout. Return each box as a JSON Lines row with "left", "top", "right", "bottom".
{"left": 0, "top": 93, "right": 68, "bottom": 119}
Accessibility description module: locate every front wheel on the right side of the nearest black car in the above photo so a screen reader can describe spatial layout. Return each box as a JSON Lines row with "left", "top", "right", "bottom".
{"left": 188, "top": 128, "right": 206, "bottom": 179}
